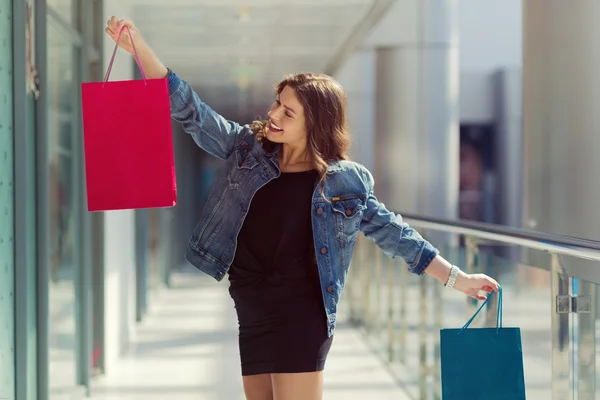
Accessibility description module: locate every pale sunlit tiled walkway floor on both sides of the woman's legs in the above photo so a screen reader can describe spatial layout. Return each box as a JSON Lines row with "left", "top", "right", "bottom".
{"left": 92, "top": 274, "right": 408, "bottom": 400}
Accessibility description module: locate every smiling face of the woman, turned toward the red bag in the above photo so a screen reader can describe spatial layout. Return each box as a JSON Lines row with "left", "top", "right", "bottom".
{"left": 267, "top": 86, "right": 308, "bottom": 146}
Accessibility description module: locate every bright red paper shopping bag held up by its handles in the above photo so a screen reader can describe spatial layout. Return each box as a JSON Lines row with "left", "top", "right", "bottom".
{"left": 81, "top": 27, "right": 177, "bottom": 211}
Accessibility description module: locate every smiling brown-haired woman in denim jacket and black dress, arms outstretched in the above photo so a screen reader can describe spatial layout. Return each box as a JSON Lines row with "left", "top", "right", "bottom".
{"left": 106, "top": 17, "right": 498, "bottom": 400}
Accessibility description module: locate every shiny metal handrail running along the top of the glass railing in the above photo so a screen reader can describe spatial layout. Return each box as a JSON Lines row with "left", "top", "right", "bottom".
{"left": 400, "top": 213, "right": 600, "bottom": 261}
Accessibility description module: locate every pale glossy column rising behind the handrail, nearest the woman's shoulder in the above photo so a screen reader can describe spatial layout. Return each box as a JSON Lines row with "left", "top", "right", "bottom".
{"left": 375, "top": 0, "right": 459, "bottom": 222}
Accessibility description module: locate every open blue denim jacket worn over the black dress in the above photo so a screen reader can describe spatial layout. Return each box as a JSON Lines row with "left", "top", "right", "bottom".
{"left": 168, "top": 71, "right": 438, "bottom": 336}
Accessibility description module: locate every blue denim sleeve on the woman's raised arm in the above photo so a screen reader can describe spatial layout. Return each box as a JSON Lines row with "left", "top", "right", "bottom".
{"left": 168, "top": 70, "right": 250, "bottom": 160}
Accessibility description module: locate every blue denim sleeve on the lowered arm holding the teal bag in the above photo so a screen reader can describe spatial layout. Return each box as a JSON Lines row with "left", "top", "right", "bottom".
{"left": 360, "top": 169, "right": 438, "bottom": 275}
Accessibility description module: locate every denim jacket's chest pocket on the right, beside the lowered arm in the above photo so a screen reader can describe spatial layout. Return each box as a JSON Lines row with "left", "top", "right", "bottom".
{"left": 331, "top": 195, "right": 367, "bottom": 242}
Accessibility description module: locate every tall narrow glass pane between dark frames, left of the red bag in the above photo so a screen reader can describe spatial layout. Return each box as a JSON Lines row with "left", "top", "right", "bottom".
{"left": 47, "top": 19, "right": 79, "bottom": 398}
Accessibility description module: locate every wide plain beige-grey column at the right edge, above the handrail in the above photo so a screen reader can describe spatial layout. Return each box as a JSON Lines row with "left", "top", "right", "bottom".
{"left": 523, "top": 0, "right": 600, "bottom": 266}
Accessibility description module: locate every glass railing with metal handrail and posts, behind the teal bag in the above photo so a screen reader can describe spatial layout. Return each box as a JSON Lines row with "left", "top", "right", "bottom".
{"left": 341, "top": 215, "right": 600, "bottom": 400}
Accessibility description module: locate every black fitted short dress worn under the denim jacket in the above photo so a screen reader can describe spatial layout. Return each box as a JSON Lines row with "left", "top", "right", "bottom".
{"left": 229, "top": 170, "right": 332, "bottom": 376}
